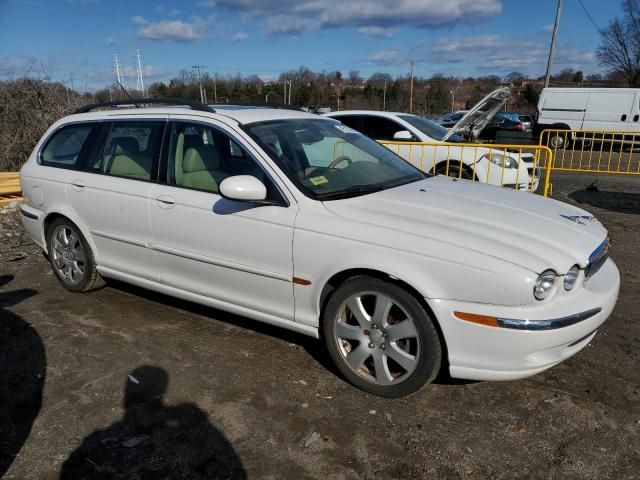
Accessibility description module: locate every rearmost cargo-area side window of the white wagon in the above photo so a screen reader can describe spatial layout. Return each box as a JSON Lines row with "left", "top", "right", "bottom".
{"left": 40, "top": 124, "right": 100, "bottom": 168}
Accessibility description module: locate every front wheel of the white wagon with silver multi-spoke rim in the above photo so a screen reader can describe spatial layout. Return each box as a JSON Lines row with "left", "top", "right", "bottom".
{"left": 322, "top": 276, "right": 442, "bottom": 398}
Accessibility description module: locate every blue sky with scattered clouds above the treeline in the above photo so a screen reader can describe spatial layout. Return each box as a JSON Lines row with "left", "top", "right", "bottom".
{"left": 0, "top": 0, "right": 621, "bottom": 91}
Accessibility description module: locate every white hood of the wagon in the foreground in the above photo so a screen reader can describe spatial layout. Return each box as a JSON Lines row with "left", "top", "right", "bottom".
{"left": 324, "top": 175, "right": 607, "bottom": 274}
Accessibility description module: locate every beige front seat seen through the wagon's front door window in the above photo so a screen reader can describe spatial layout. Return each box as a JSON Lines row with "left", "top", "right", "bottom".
{"left": 180, "top": 145, "right": 229, "bottom": 193}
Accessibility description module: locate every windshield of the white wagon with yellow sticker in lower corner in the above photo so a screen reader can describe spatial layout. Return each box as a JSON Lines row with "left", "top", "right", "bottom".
{"left": 244, "top": 119, "right": 427, "bottom": 200}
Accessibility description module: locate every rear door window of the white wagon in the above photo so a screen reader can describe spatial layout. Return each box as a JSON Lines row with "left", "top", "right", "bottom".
{"left": 89, "top": 121, "right": 165, "bottom": 180}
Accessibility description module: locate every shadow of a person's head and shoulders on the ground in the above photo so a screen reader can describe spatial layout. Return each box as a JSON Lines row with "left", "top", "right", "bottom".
{"left": 60, "top": 366, "right": 246, "bottom": 480}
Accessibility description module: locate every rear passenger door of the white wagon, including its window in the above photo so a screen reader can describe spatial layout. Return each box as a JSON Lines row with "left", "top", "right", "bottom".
{"left": 67, "top": 117, "right": 166, "bottom": 280}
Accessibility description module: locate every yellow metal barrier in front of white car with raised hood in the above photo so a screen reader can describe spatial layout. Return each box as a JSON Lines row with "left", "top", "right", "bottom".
{"left": 333, "top": 141, "right": 553, "bottom": 196}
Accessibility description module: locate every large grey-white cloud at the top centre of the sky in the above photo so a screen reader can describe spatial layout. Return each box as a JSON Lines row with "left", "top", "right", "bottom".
{"left": 210, "top": 0, "right": 502, "bottom": 34}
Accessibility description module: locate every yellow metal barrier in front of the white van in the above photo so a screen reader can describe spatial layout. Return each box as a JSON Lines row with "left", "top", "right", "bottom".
{"left": 539, "top": 129, "right": 640, "bottom": 175}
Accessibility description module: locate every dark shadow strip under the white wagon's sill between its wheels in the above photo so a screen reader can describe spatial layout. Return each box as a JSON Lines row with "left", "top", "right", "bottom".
{"left": 107, "top": 279, "right": 344, "bottom": 380}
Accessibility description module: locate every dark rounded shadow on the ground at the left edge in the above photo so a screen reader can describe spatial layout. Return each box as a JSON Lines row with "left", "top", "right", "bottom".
{"left": 0, "top": 275, "right": 47, "bottom": 478}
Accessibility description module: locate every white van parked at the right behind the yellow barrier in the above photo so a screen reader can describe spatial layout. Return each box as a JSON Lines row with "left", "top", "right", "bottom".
{"left": 537, "top": 88, "right": 640, "bottom": 148}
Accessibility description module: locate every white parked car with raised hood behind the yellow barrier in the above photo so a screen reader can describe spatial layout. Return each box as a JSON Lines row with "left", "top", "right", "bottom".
{"left": 325, "top": 89, "right": 540, "bottom": 192}
